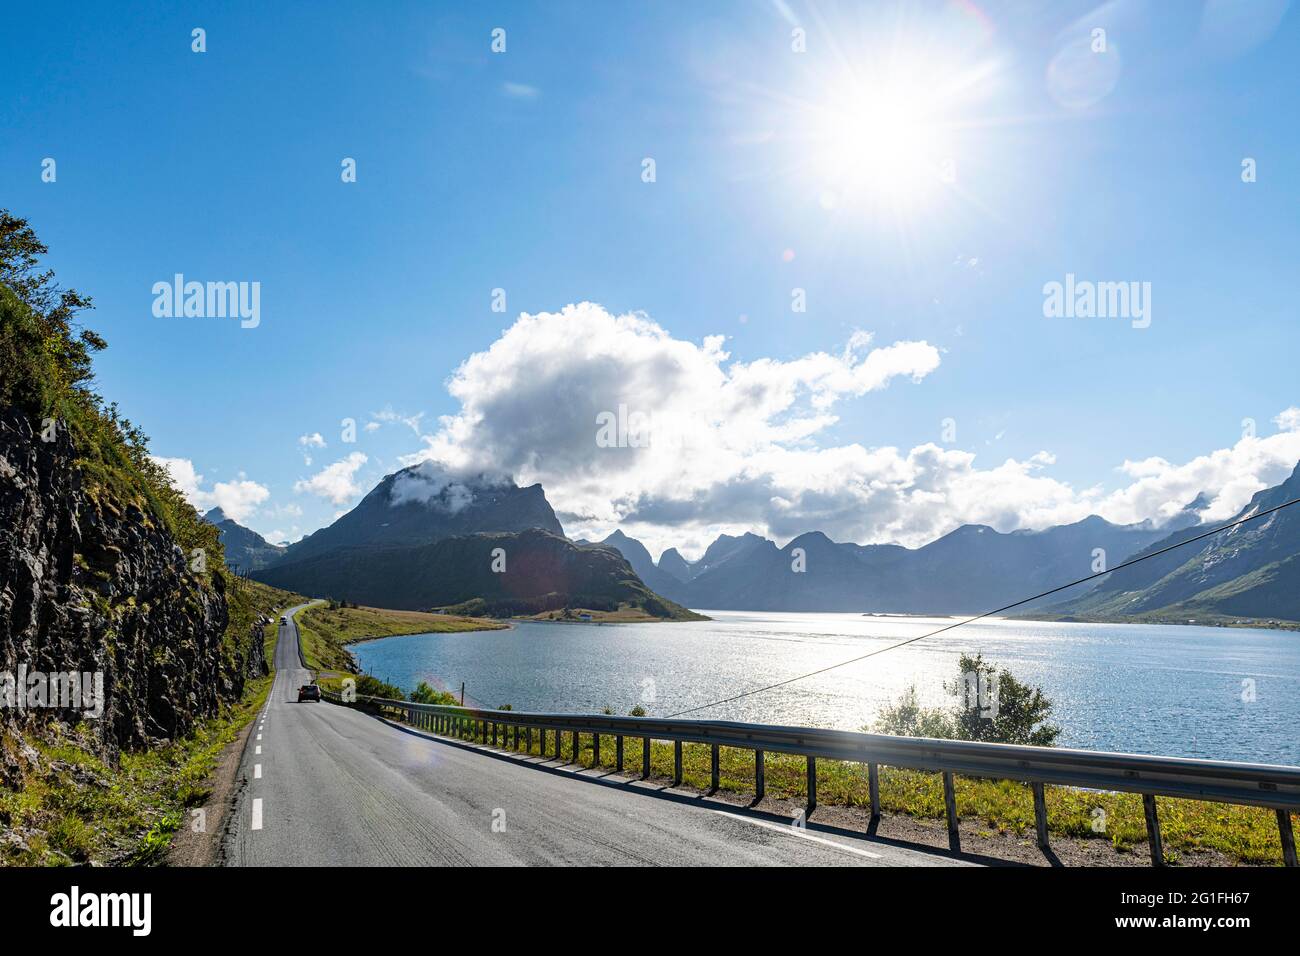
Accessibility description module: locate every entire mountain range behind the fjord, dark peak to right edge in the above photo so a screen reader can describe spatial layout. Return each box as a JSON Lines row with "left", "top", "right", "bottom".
{"left": 239, "top": 464, "right": 1300, "bottom": 619}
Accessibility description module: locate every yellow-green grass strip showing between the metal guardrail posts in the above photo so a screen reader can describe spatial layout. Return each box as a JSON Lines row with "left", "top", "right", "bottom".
{"left": 408, "top": 717, "right": 1300, "bottom": 866}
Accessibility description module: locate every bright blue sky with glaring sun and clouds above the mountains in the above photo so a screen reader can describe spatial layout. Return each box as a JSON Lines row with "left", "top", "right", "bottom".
{"left": 0, "top": 0, "right": 1300, "bottom": 550}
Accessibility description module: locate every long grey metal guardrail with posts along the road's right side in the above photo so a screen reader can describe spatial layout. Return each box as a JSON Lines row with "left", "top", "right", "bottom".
{"left": 322, "top": 691, "right": 1300, "bottom": 866}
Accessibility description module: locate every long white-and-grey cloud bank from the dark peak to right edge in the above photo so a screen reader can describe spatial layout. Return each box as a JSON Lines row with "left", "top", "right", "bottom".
{"left": 403, "top": 303, "right": 1300, "bottom": 554}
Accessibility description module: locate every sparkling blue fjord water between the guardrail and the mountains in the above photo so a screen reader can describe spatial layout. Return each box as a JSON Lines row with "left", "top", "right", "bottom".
{"left": 352, "top": 611, "right": 1300, "bottom": 765}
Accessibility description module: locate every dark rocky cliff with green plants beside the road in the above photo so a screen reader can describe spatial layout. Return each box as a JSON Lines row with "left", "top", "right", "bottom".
{"left": 0, "top": 408, "right": 267, "bottom": 777}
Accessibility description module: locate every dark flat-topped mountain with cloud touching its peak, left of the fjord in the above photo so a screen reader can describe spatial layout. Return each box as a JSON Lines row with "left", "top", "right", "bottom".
{"left": 250, "top": 464, "right": 698, "bottom": 620}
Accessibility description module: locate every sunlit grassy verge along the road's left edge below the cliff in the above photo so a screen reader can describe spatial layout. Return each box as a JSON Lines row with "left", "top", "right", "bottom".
{"left": 0, "top": 574, "right": 302, "bottom": 866}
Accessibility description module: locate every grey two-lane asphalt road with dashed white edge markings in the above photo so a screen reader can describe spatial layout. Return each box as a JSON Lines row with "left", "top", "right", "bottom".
{"left": 221, "top": 605, "right": 969, "bottom": 866}
